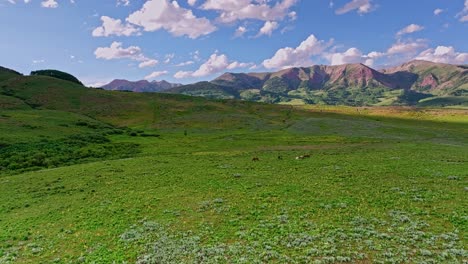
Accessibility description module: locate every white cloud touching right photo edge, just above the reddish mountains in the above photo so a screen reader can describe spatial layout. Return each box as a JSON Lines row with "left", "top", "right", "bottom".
{"left": 416, "top": 46, "right": 468, "bottom": 64}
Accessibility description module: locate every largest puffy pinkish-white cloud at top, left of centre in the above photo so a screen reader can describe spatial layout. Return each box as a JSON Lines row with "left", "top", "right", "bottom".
{"left": 127, "top": 0, "right": 216, "bottom": 39}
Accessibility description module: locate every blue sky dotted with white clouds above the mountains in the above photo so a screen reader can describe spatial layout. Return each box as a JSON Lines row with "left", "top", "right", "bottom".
{"left": 0, "top": 0, "right": 468, "bottom": 86}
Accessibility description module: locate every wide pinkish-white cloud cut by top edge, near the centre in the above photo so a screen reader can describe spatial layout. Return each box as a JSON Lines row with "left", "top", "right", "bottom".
{"left": 202, "top": 0, "right": 297, "bottom": 23}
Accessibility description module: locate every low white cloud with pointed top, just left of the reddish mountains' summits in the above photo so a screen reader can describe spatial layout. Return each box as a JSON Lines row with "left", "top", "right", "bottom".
{"left": 174, "top": 53, "right": 253, "bottom": 79}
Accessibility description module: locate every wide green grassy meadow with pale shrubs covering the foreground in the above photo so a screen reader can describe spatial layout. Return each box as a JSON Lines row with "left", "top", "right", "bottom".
{"left": 0, "top": 73, "right": 468, "bottom": 263}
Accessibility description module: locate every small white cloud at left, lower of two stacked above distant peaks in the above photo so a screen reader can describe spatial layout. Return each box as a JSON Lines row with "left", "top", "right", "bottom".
{"left": 94, "top": 41, "right": 158, "bottom": 68}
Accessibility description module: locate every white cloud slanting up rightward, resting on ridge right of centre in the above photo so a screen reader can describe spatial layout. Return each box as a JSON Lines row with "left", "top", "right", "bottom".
{"left": 263, "top": 35, "right": 333, "bottom": 69}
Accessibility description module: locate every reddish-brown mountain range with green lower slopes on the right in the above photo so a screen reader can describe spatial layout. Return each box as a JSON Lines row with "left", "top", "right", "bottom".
{"left": 164, "top": 61, "right": 468, "bottom": 106}
